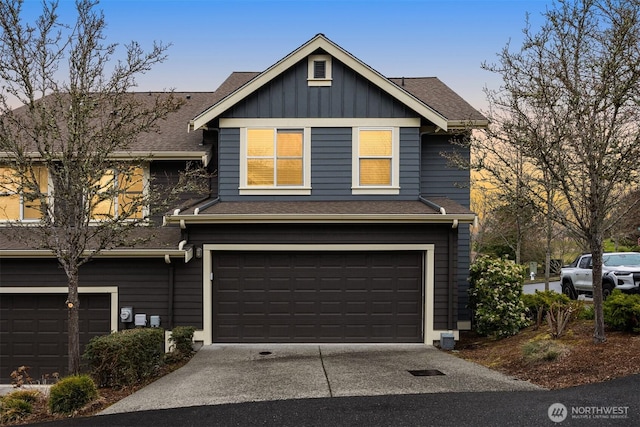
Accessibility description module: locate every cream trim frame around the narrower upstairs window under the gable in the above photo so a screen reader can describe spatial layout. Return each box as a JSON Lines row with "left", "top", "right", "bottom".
{"left": 351, "top": 127, "right": 400, "bottom": 195}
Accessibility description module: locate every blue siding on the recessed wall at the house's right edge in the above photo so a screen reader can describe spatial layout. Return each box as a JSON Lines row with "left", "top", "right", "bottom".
{"left": 420, "top": 135, "right": 471, "bottom": 321}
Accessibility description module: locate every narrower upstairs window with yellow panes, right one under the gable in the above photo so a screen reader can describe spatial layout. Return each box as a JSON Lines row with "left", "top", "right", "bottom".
{"left": 352, "top": 128, "right": 400, "bottom": 194}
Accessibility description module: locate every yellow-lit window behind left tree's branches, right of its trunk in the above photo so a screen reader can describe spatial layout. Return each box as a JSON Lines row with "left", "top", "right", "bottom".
{"left": 92, "top": 166, "right": 146, "bottom": 221}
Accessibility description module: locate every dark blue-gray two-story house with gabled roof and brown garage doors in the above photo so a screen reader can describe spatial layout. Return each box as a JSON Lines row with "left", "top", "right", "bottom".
{"left": 0, "top": 34, "right": 487, "bottom": 381}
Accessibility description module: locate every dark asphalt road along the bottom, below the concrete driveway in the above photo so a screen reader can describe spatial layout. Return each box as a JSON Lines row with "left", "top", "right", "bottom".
{"left": 27, "top": 375, "right": 640, "bottom": 427}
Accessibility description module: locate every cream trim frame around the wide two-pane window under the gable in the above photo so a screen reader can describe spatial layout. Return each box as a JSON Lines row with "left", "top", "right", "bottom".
{"left": 238, "top": 126, "right": 311, "bottom": 196}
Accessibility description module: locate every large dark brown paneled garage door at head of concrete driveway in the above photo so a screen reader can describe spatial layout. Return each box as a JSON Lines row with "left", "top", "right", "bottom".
{"left": 213, "top": 251, "right": 423, "bottom": 343}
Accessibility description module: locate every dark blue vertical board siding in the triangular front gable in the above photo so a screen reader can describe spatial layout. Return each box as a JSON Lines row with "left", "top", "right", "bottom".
{"left": 221, "top": 58, "right": 418, "bottom": 118}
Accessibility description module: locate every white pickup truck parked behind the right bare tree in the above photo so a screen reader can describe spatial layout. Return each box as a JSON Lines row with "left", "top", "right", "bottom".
{"left": 560, "top": 252, "right": 640, "bottom": 299}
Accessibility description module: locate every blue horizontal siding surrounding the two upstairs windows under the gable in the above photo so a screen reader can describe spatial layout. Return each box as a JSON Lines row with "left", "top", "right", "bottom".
{"left": 218, "top": 127, "right": 420, "bottom": 201}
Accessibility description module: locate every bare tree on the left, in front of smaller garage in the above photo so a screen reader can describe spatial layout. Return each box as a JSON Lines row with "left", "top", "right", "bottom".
{"left": 0, "top": 0, "right": 180, "bottom": 373}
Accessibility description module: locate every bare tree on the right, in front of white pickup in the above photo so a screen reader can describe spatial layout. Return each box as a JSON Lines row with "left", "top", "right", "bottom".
{"left": 483, "top": 0, "right": 640, "bottom": 342}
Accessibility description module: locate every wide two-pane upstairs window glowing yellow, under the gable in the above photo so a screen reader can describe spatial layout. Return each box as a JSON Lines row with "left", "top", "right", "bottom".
{"left": 240, "top": 128, "right": 310, "bottom": 194}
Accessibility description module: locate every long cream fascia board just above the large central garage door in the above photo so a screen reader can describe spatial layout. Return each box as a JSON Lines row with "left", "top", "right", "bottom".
{"left": 164, "top": 214, "right": 476, "bottom": 224}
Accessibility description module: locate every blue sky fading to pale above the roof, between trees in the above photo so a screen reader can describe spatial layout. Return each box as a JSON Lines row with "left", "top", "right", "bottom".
{"left": 15, "top": 0, "right": 551, "bottom": 111}
